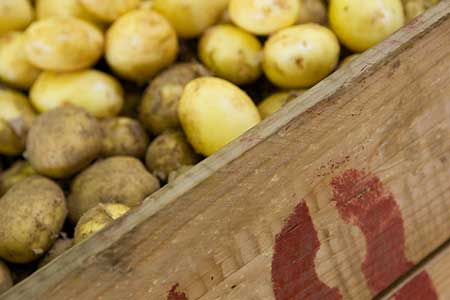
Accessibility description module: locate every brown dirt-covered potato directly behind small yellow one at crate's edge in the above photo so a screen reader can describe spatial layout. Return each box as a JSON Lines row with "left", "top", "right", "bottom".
{"left": 67, "top": 156, "right": 159, "bottom": 223}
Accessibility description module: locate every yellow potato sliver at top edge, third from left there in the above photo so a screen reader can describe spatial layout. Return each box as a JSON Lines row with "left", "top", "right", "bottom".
{"left": 78, "top": 0, "right": 141, "bottom": 22}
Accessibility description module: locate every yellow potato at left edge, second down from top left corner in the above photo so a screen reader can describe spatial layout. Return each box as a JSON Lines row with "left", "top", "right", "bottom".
{"left": 0, "top": 31, "right": 40, "bottom": 89}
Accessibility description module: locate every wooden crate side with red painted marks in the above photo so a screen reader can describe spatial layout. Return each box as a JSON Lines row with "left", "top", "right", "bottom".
{"left": 1, "top": 0, "right": 450, "bottom": 300}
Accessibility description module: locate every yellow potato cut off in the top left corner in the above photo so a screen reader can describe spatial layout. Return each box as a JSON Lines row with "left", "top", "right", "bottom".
{"left": 0, "top": 0, "right": 34, "bottom": 35}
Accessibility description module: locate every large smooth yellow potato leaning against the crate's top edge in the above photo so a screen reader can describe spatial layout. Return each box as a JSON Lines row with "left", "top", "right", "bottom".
{"left": 178, "top": 77, "right": 261, "bottom": 156}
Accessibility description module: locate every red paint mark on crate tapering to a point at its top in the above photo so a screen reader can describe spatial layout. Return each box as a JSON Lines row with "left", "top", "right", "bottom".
{"left": 272, "top": 202, "right": 342, "bottom": 300}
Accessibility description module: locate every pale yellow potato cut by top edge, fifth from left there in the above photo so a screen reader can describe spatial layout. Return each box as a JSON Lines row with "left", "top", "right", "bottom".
{"left": 228, "top": 0, "right": 300, "bottom": 35}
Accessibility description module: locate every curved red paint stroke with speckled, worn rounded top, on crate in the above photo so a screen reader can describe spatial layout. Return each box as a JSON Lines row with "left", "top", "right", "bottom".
{"left": 331, "top": 170, "right": 433, "bottom": 294}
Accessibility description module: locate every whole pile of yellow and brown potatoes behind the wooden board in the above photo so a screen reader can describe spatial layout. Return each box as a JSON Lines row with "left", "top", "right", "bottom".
{"left": 0, "top": 0, "right": 437, "bottom": 293}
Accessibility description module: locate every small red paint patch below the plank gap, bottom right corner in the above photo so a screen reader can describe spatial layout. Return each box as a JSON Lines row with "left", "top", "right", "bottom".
{"left": 392, "top": 272, "right": 438, "bottom": 300}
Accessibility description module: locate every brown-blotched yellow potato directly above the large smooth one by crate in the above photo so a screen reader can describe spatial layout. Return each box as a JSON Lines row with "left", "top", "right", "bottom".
{"left": 198, "top": 25, "right": 262, "bottom": 84}
